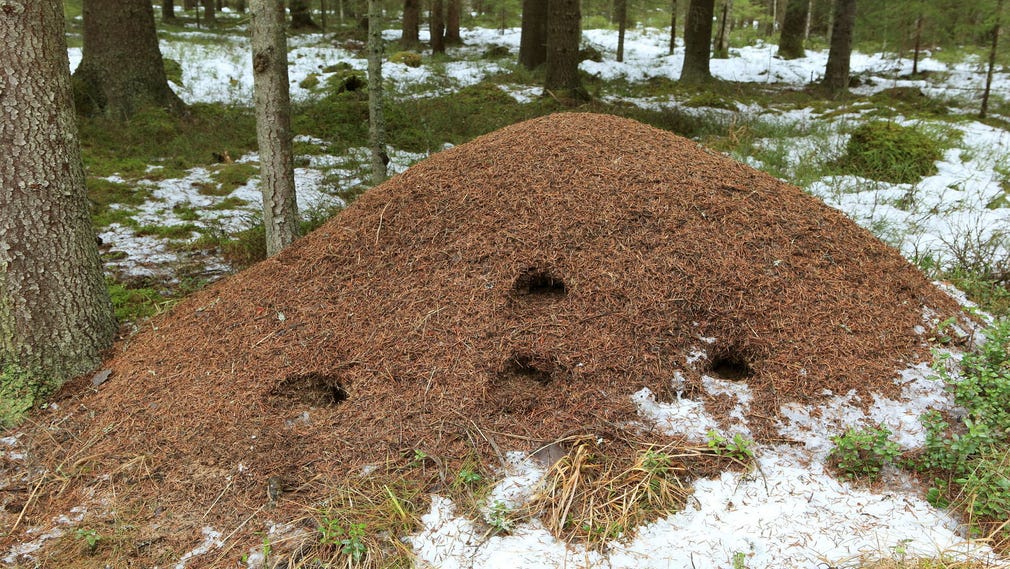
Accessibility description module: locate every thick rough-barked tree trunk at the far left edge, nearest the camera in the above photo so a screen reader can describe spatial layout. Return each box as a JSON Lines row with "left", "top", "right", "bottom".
{"left": 0, "top": 0, "right": 116, "bottom": 391}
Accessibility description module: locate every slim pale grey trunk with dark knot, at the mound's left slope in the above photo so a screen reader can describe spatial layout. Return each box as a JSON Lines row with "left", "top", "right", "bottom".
{"left": 249, "top": 0, "right": 299, "bottom": 256}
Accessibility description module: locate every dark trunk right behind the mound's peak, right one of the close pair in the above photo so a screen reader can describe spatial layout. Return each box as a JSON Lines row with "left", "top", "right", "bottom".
{"left": 543, "top": 0, "right": 589, "bottom": 99}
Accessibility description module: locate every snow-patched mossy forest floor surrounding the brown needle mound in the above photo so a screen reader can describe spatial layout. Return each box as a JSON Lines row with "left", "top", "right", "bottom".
{"left": 0, "top": 7, "right": 1010, "bottom": 569}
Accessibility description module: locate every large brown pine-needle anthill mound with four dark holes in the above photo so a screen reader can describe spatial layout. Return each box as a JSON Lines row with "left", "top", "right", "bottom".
{"left": 0, "top": 113, "right": 957, "bottom": 552}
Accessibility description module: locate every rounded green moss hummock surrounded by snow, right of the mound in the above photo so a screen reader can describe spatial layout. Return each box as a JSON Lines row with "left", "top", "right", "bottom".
{"left": 838, "top": 121, "right": 943, "bottom": 184}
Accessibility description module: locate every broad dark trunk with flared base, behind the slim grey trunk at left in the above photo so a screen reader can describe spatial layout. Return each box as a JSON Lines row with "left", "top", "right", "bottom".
{"left": 73, "top": 0, "right": 185, "bottom": 119}
